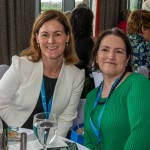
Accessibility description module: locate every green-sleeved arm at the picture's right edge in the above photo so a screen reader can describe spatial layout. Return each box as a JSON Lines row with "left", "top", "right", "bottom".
{"left": 124, "top": 77, "right": 150, "bottom": 150}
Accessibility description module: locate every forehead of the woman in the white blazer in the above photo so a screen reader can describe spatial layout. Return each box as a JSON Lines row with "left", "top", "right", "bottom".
{"left": 39, "top": 19, "right": 64, "bottom": 32}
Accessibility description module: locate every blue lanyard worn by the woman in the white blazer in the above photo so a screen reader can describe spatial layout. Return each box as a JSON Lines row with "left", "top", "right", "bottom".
{"left": 41, "top": 79, "right": 53, "bottom": 112}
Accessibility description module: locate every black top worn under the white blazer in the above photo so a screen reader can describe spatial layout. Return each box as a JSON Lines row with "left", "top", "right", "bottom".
{"left": 22, "top": 76, "right": 57, "bottom": 129}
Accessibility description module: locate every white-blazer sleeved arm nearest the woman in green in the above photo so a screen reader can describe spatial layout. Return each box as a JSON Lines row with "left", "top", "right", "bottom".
{"left": 58, "top": 70, "right": 85, "bottom": 137}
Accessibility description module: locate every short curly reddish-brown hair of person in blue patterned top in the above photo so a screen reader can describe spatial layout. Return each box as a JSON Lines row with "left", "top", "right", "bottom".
{"left": 127, "top": 9, "right": 150, "bottom": 35}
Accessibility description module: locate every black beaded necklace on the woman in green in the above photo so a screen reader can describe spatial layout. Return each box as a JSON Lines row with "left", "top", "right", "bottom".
{"left": 96, "top": 71, "right": 126, "bottom": 105}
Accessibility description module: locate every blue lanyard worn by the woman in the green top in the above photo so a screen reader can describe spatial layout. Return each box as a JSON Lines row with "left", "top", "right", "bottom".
{"left": 90, "top": 72, "right": 126, "bottom": 144}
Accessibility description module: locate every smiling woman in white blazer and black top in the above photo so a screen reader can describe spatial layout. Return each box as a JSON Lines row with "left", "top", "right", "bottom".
{"left": 0, "top": 10, "right": 85, "bottom": 137}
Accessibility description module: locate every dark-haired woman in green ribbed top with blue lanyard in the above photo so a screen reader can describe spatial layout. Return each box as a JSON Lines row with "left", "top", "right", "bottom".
{"left": 84, "top": 28, "right": 150, "bottom": 150}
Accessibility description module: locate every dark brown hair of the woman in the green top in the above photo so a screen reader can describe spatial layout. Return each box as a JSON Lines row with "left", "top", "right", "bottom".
{"left": 88, "top": 28, "right": 133, "bottom": 72}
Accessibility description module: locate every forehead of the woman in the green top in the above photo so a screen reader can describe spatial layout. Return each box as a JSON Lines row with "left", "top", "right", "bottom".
{"left": 100, "top": 35, "right": 126, "bottom": 49}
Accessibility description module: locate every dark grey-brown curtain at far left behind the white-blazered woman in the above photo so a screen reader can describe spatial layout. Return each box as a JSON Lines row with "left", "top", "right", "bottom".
{"left": 0, "top": 0, "right": 35, "bottom": 65}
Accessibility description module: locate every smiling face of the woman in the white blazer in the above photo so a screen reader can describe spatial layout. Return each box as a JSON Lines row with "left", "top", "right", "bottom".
{"left": 36, "top": 19, "right": 69, "bottom": 59}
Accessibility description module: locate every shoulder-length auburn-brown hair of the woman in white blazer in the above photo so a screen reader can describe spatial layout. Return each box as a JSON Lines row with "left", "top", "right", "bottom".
{"left": 20, "top": 10, "right": 79, "bottom": 64}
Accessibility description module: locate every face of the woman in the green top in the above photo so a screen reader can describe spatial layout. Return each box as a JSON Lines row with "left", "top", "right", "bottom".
{"left": 96, "top": 35, "right": 128, "bottom": 76}
